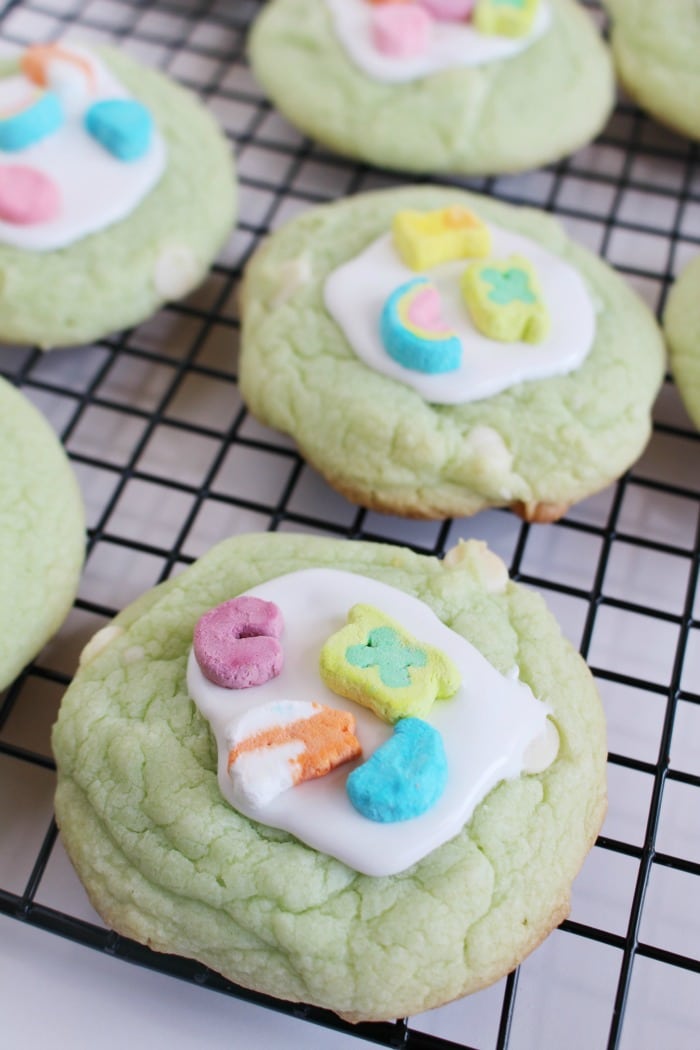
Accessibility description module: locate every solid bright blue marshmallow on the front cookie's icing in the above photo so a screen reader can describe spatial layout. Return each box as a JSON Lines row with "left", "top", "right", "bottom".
{"left": 346, "top": 718, "right": 448, "bottom": 824}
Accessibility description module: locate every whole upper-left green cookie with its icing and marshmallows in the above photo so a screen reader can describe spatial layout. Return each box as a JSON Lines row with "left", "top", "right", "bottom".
{"left": 0, "top": 44, "right": 236, "bottom": 349}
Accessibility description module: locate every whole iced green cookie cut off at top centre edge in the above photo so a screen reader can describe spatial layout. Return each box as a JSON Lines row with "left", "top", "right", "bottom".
{"left": 249, "top": 0, "right": 614, "bottom": 174}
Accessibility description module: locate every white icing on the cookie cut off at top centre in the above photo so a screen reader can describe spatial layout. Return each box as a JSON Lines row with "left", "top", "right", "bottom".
{"left": 325, "top": 0, "right": 552, "bottom": 84}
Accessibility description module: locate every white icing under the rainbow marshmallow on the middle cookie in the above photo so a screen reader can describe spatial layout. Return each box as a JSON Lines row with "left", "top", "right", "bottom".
{"left": 323, "top": 225, "right": 595, "bottom": 404}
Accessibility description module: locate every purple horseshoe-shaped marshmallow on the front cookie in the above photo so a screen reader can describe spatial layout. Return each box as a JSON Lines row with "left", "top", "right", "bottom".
{"left": 193, "top": 595, "right": 284, "bottom": 689}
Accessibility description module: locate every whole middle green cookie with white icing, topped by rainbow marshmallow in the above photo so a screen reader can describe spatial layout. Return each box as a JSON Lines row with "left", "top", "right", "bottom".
{"left": 239, "top": 187, "right": 664, "bottom": 521}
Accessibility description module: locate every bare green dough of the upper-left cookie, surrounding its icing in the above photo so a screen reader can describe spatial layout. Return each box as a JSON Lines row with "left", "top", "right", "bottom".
{"left": 0, "top": 47, "right": 236, "bottom": 350}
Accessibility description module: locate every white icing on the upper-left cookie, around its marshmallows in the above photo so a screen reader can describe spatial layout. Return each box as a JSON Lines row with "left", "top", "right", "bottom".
{"left": 0, "top": 45, "right": 166, "bottom": 252}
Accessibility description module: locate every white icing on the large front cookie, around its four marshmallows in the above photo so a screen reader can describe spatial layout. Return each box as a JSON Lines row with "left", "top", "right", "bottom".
{"left": 187, "top": 569, "right": 554, "bottom": 876}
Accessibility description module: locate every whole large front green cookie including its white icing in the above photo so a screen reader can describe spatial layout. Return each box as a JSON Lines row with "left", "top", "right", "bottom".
{"left": 52, "top": 533, "right": 607, "bottom": 1021}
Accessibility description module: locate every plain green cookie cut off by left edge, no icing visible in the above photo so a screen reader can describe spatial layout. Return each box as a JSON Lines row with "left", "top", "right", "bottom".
{"left": 0, "top": 379, "right": 85, "bottom": 689}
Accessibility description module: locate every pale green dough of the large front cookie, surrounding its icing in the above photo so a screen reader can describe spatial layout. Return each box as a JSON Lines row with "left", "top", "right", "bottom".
{"left": 54, "top": 533, "right": 606, "bottom": 1021}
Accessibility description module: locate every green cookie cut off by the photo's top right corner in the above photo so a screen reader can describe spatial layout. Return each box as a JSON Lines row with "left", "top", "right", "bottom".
{"left": 603, "top": 0, "right": 700, "bottom": 139}
